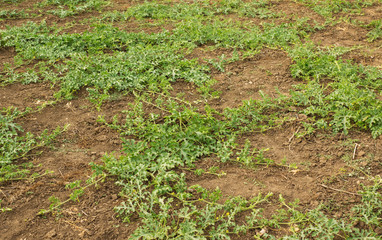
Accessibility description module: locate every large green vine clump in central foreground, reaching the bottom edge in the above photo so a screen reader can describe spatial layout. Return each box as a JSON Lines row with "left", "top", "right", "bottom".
{"left": 94, "top": 96, "right": 286, "bottom": 239}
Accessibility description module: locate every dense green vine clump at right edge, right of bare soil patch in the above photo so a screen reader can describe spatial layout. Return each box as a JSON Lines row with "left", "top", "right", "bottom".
{"left": 290, "top": 43, "right": 382, "bottom": 137}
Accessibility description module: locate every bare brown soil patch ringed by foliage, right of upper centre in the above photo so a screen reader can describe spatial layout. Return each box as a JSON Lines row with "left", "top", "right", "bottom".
{"left": 213, "top": 49, "right": 298, "bottom": 109}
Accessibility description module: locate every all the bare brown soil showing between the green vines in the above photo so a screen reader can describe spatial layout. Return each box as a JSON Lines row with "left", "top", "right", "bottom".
{"left": 0, "top": 0, "right": 382, "bottom": 240}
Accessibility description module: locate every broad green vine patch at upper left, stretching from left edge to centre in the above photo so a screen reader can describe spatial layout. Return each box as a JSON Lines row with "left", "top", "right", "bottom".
{"left": 1, "top": 23, "right": 211, "bottom": 98}
